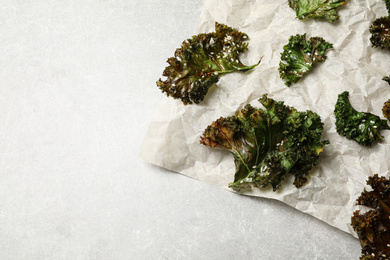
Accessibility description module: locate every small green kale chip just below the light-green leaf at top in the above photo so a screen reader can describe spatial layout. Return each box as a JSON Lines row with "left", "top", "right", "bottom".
{"left": 279, "top": 34, "right": 333, "bottom": 86}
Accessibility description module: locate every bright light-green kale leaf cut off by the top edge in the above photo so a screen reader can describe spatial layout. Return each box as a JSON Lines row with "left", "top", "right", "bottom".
{"left": 288, "top": 0, "right": 346, "bottom": 23}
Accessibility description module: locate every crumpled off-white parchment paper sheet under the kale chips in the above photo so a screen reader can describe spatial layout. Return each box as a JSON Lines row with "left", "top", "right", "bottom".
{"left": 140, "top": 0, "right": 390, "bottom": 236}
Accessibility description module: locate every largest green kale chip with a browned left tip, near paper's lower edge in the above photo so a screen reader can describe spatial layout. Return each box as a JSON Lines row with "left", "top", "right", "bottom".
{"left": 201, "top": 95, "right": 329, "bottom": 191}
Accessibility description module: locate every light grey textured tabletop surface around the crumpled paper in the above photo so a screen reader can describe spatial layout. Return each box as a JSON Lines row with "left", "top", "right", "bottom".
{"left": 0, "top": 0, "right": 360, "bottom": 259}
